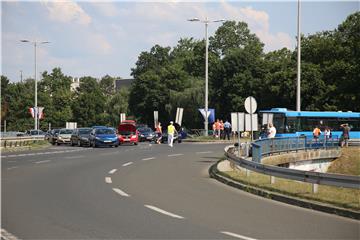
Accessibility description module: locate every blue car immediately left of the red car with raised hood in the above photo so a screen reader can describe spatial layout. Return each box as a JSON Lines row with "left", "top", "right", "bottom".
{"left": 89, "top": 127, "right": 119, "bottom": 147}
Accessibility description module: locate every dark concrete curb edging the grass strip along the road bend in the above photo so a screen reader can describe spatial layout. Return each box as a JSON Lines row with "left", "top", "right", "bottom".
{"left": 209, "top": 161, "right": 360, "bottom": 220}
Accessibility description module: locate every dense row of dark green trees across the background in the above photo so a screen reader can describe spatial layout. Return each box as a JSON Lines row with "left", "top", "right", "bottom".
{"left": 1, "top": 12, "right": 360, "bottom": 130}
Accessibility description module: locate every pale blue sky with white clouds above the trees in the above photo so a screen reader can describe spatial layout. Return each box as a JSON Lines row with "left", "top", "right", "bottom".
{"left": 1, "top": 0, "right": 360, "bottom": 82}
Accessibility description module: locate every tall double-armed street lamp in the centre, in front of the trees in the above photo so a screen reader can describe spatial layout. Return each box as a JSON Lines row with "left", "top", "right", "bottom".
{"left": 188, "top": 17, "right": 225, "bottom": 136}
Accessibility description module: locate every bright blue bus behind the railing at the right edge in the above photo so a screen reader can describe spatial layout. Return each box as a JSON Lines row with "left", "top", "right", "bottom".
{"left": 259, "top": 108, "right": 360, "bottom": 141}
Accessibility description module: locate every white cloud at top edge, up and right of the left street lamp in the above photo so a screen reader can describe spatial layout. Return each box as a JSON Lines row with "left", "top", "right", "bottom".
{"left": 42, "top": 0, "right": 91, "bottom": 25}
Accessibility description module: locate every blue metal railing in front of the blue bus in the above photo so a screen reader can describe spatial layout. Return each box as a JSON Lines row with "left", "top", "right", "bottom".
{"left": 251, "top": 136, "right": 339, "bottom": 163}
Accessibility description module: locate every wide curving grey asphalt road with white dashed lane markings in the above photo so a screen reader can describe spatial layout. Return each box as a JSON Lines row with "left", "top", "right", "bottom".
{"left": 1, "top": 143, "right": 360, "bottom": 240}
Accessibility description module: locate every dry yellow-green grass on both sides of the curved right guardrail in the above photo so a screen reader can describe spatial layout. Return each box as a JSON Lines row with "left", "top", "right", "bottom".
{"left": 221, "top": 147, "right": 360, "bottom": 211}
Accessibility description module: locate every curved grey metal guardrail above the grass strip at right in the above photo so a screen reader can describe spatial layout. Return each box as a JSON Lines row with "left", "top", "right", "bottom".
{"left": 225, "top": 142, "right": 360, "bottom": 189}
